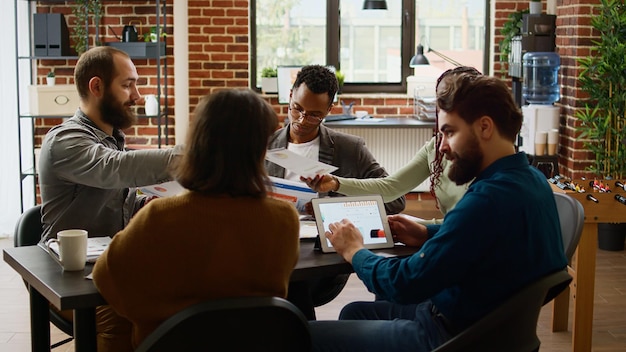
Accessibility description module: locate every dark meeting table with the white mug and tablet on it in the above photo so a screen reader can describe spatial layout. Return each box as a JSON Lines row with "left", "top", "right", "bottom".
{"left": 3, "top": 241, "right": 416, "bottom": 352}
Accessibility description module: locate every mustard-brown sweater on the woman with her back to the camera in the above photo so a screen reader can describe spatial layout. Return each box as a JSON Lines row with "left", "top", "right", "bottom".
{"left": 93, "top": 192, "right": 299, "bottom": 347}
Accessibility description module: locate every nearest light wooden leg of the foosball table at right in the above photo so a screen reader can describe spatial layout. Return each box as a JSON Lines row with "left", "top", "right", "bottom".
{"left": 572, "top": 223, "right": 598, "bottom": 352}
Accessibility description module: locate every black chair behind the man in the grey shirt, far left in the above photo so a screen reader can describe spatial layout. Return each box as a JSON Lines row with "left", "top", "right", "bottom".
{"left": 13, "top": 205, "right": 74, "bottom": 349}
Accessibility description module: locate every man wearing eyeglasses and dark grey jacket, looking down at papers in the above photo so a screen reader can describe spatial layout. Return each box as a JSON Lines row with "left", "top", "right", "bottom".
{"left": 265, "top": 65, "right": 405, "bottom": 320}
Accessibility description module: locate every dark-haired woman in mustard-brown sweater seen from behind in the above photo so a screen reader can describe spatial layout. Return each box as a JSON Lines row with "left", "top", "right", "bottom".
{"left": 93, "top": 90, "right": 299, "bottom": 347}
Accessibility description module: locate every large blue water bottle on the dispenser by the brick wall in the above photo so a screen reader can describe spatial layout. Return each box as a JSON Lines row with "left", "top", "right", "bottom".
{"left": 522, "top": 52, "right": 561, "bottom": 105}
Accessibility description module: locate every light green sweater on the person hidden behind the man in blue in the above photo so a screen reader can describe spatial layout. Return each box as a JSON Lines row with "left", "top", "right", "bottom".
{"left": 337, "top": 138, "right": 469, "bottom": 223}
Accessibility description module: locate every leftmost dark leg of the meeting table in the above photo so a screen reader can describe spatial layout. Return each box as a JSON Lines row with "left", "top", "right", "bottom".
{"left": 29, "top": 287, "right": 50, "bottom": 352}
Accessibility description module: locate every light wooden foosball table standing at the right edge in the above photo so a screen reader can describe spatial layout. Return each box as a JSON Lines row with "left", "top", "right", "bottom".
{"left": 552, "top": 180, "right": 626, "bottom": 352}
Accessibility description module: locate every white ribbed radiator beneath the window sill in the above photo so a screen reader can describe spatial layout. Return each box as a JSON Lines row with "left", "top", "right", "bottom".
{"left": 333, "top": 126, "right": 433, "bottom": 192}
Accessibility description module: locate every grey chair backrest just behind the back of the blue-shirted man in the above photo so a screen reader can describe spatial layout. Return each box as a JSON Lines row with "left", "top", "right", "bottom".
{"left": 554, "top": 192, "right": 585, "bottom": 261}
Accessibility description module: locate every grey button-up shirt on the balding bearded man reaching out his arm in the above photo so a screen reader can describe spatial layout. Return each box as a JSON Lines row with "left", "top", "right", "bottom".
{"left": 39, "top": 109, "right": 180, "bottom": 241}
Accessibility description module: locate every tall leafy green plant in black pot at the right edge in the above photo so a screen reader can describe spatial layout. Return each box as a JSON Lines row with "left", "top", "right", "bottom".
{"left": 575, "top": 0, "right": 626, "bottom": 250}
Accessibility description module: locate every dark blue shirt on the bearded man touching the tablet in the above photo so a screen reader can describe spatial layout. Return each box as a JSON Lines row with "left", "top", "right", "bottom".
{"left": 352, "top": 153, "right": 567, "bottom": 329}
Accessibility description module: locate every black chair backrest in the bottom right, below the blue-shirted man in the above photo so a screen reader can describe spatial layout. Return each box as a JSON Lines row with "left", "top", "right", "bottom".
{"left": 434, "top": 270, "right": 572, "bottom": 352}
